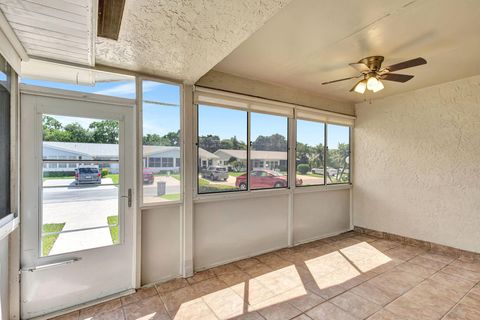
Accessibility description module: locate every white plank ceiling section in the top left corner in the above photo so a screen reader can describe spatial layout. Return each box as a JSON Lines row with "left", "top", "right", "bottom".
{"left": 0, "top": 0, "right": 96, "bottom": 66}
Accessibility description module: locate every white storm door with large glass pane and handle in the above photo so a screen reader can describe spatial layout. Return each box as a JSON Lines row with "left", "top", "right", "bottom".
{"left": 21, "top": 91, "right": 135, "bottom": 318}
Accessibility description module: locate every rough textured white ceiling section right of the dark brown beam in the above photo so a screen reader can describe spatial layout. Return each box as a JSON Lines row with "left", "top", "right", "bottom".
{"left": 96, "top": 0, "right": 290, "bottom": 83}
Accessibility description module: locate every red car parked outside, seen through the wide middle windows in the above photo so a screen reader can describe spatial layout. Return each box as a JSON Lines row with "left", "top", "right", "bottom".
{"left": 235, "top": 170, "right": 303, "bottom": 190}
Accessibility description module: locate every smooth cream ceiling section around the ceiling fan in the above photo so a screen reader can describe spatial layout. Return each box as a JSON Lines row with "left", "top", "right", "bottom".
{"left": 214, "top": 0, "right": 480, "bottom": 102}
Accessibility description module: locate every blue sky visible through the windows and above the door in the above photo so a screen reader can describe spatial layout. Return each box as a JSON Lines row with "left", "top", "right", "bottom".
{"left": 22, "top": 78, "right": 349, "bottom": 147}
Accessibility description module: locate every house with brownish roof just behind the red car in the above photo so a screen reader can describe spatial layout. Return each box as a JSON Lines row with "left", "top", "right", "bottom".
{"left": 215, "top": 149, "right": 287, "bottom": 170}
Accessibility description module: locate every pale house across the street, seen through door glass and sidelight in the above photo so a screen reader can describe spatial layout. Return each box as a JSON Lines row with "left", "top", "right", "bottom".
{"left": 43, "top": 141, "right": 218, "bottom": 173}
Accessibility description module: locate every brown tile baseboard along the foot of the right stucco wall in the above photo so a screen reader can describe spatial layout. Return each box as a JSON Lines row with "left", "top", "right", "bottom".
{"left": 354, "top": 226, "right": 480, "bottom": 259}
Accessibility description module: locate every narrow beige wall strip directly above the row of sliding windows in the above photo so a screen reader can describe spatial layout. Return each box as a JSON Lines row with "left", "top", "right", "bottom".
{"left": 196, "top": 71, "right": 355, "bottom": 115}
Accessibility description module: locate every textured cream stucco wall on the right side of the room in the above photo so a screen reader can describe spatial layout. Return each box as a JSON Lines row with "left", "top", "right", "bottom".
{"left": 354, "top": 76, "right": 480, "bottom": 252}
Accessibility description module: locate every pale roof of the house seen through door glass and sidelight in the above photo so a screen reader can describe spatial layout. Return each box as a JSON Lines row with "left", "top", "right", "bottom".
{"left": 43, "top": 141, "right": 218, "bottom": 159}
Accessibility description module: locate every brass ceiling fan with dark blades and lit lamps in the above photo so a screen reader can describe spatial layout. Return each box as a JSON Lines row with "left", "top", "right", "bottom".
{"left": 322, "top": 56, "right": 427, "bottom": 94}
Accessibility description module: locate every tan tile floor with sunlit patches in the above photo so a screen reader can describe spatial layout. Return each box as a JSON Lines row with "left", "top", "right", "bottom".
{"left": 50, "top": 232, "right": 480, "bottom": 320}
